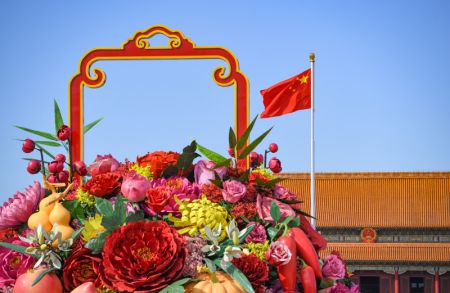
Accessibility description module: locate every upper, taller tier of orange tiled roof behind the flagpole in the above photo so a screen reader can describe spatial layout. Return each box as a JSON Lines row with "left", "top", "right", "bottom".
{"left": 282, "top": 172, "right": 450, "bottom": 228}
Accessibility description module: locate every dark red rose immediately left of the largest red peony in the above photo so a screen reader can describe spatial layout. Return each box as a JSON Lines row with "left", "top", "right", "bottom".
{"left": 62, "top": 248, "right": 102, "bottom": 291}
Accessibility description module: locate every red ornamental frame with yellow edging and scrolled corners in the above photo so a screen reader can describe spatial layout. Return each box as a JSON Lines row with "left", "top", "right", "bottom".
{"left": 69, "top": 25, "right": 249, "bottom": 175}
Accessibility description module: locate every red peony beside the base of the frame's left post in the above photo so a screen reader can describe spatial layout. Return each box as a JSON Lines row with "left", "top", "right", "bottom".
{"left": 81, "top": 173, "right": 121, "bottom": 197}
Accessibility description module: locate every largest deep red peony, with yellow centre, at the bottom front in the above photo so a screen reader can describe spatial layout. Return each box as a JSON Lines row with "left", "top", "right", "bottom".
{"left": 100, "top": 221, "right": 187, "bottom": 292}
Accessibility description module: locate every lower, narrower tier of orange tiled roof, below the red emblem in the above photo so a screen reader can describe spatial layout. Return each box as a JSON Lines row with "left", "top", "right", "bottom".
{"left": 320, "top": 242, "right": 450, "bottom": 263}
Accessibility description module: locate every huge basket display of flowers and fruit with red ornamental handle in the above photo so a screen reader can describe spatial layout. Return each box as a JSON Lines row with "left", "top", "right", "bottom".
{"left": 0, "top": 27, "right": 359, "bottom": 293}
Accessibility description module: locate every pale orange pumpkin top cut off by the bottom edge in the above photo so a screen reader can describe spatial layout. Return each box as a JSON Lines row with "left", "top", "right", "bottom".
{"left": 184, "top": 272, "right": 246, "bottom": 293}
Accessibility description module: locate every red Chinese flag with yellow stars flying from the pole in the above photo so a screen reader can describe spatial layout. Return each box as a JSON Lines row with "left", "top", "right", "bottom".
{"left": 260, "top": 69, "right": 311, "bottom": 118}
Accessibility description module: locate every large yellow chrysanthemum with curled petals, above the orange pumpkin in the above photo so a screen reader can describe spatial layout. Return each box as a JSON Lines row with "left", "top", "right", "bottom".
{"left": 169, "top": 195, "right": 231, "bottom": 241}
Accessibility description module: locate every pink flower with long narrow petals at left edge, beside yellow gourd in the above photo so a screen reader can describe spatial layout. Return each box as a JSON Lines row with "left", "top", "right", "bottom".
{"left": 0, "top": 181, "right": 44, "bottom": 228}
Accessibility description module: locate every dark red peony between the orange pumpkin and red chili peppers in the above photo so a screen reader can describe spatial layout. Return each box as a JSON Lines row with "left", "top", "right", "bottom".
{"left": 231, "top": 253, "right": 269, "bottom": 292}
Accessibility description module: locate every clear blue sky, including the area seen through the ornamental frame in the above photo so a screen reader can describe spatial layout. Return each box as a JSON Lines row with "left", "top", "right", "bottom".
{"left": 0, "top": 0, "right": 450, "bottom": 201}
